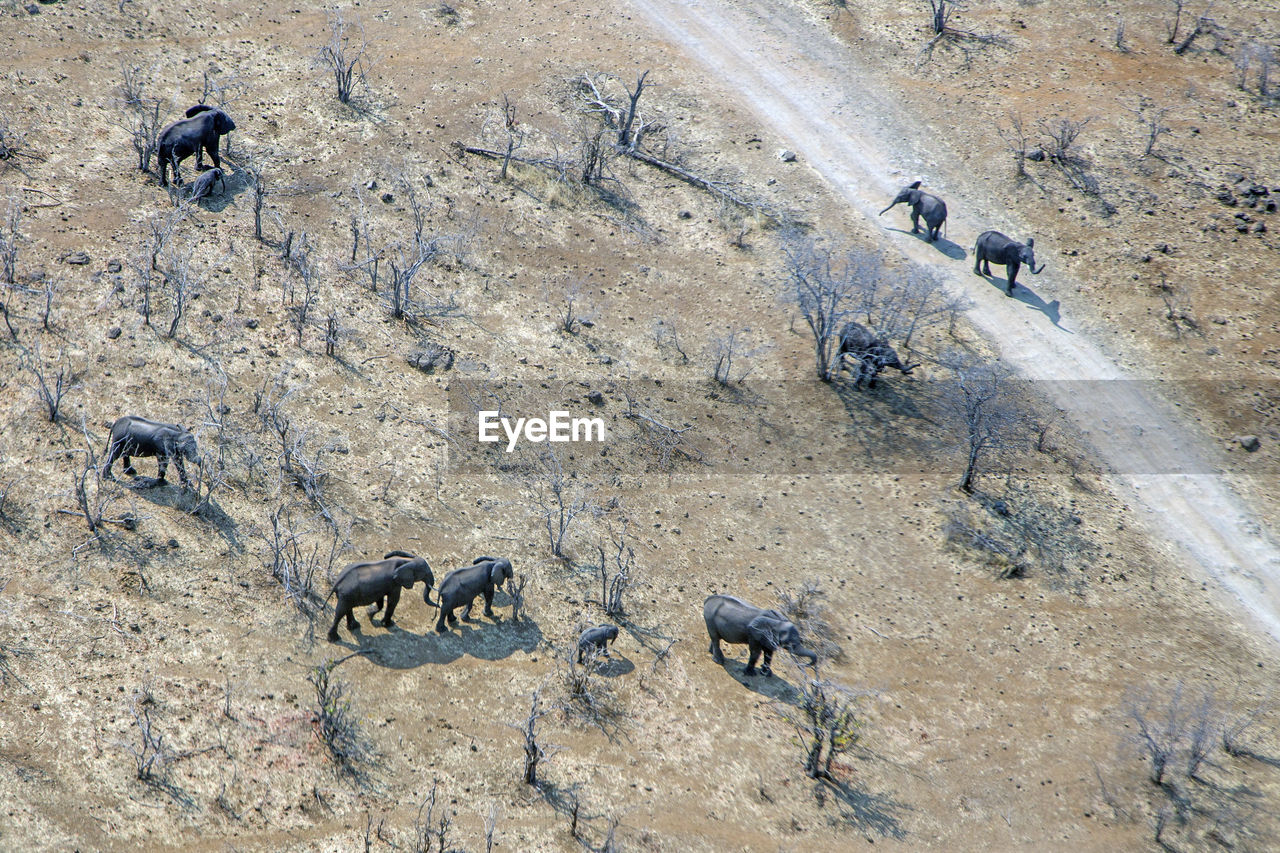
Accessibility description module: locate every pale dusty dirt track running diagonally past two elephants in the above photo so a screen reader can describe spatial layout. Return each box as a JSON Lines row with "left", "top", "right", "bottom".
{"left": 631, "top": 0, "right": 1280, "bottom": 640}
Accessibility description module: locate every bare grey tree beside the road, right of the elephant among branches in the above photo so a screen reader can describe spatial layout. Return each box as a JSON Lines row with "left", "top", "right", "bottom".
{"left": 940, "top": 351, "right": 1021, "bottom": 493}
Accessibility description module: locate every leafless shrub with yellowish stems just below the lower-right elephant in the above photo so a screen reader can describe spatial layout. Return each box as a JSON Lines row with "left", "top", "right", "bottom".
{"left": 773, "top": 665, "right": 865, "bottom": 781}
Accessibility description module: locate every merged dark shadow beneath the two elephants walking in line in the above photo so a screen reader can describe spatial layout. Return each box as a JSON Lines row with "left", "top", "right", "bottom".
{"left": 339, "top": 619, "right": 543, "bottom": 670}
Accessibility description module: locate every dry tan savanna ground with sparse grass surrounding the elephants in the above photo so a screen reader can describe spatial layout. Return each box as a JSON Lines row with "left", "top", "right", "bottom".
{"left": 0, "top": 0, "right": 1280, "bottom": 850}
